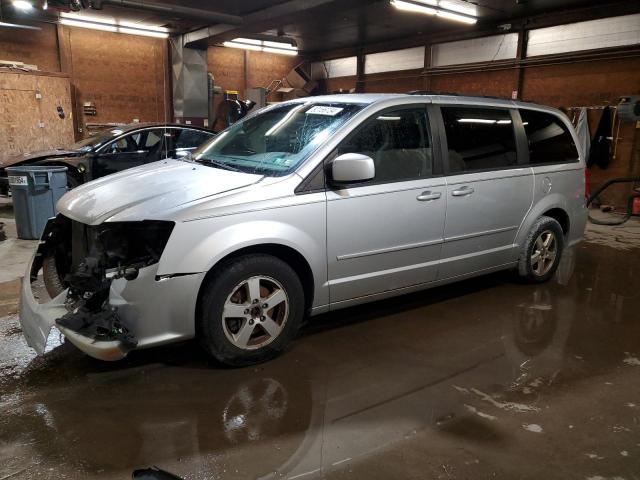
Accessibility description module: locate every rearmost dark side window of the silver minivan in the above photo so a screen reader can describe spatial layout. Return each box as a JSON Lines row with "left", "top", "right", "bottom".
{"left": 520, "top": 110, "right": 579, "bottom": 165}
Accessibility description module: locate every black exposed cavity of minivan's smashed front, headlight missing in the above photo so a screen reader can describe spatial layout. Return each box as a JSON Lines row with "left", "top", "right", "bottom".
{"left": 31, "top": 215, "right": 174, "bottom": 348}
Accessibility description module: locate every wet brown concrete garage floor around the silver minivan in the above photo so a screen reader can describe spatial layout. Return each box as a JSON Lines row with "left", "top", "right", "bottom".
{"left": 0, "top": 201, "right": 640, "bottom": 480}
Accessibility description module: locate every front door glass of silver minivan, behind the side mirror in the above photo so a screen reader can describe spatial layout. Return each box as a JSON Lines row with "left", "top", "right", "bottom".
{"left": 338, "top": 106, "right": 433, "bottom": 183}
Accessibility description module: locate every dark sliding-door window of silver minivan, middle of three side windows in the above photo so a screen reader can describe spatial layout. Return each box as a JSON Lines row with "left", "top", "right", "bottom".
{"left": 441, "top": 107, "right": 518, "bottom": 173}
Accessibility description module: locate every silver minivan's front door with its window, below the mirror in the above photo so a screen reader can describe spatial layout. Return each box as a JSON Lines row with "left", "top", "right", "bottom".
{"left": 327, "top": 105, "right": 446, "bottom": 303}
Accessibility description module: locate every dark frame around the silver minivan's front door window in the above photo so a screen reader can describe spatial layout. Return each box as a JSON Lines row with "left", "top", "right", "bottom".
{"left": 324, "top": 102, "right": 444, "bottom": 193}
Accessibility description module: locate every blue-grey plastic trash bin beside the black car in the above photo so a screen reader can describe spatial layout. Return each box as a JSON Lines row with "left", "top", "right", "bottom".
{"left": 6, "top": 166, "right": 67, "bottom": 240}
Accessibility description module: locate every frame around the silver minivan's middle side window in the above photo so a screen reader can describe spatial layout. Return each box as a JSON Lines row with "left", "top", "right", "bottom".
{"left": 433, "top": 103, "right": 529, "bottom": 177}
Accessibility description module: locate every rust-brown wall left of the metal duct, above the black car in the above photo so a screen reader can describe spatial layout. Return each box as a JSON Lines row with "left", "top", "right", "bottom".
{"left": 0, "top": 23, "right": 170, "bottom": 146}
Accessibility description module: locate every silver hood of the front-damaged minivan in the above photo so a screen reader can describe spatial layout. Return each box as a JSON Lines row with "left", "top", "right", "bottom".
{"left": 57, "top": 159, "right": 262, "bottom": 225}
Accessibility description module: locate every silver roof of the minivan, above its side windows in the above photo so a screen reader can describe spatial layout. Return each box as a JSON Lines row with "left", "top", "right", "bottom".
{"left": 294, "top": 91, "right": 562, "bottom": 114}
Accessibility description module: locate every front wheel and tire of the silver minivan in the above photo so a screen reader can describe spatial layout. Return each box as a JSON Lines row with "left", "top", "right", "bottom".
{"left": 198, "top": 254, "right": 305, "bottom": 367}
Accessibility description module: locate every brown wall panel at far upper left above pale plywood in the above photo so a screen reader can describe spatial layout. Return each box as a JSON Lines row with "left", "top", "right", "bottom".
{"left": 0, "top": 23, "right": 60, "bottom": 72}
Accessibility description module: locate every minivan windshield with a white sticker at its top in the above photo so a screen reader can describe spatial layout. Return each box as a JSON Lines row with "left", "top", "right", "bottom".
{"left": 193, "top": 102, "right": 364, "bottom": 176}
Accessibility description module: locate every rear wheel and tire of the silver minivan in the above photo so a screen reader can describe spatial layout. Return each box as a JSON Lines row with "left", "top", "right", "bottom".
{"left": 518, "top": 216, "right": 564, "bottom": 283}
